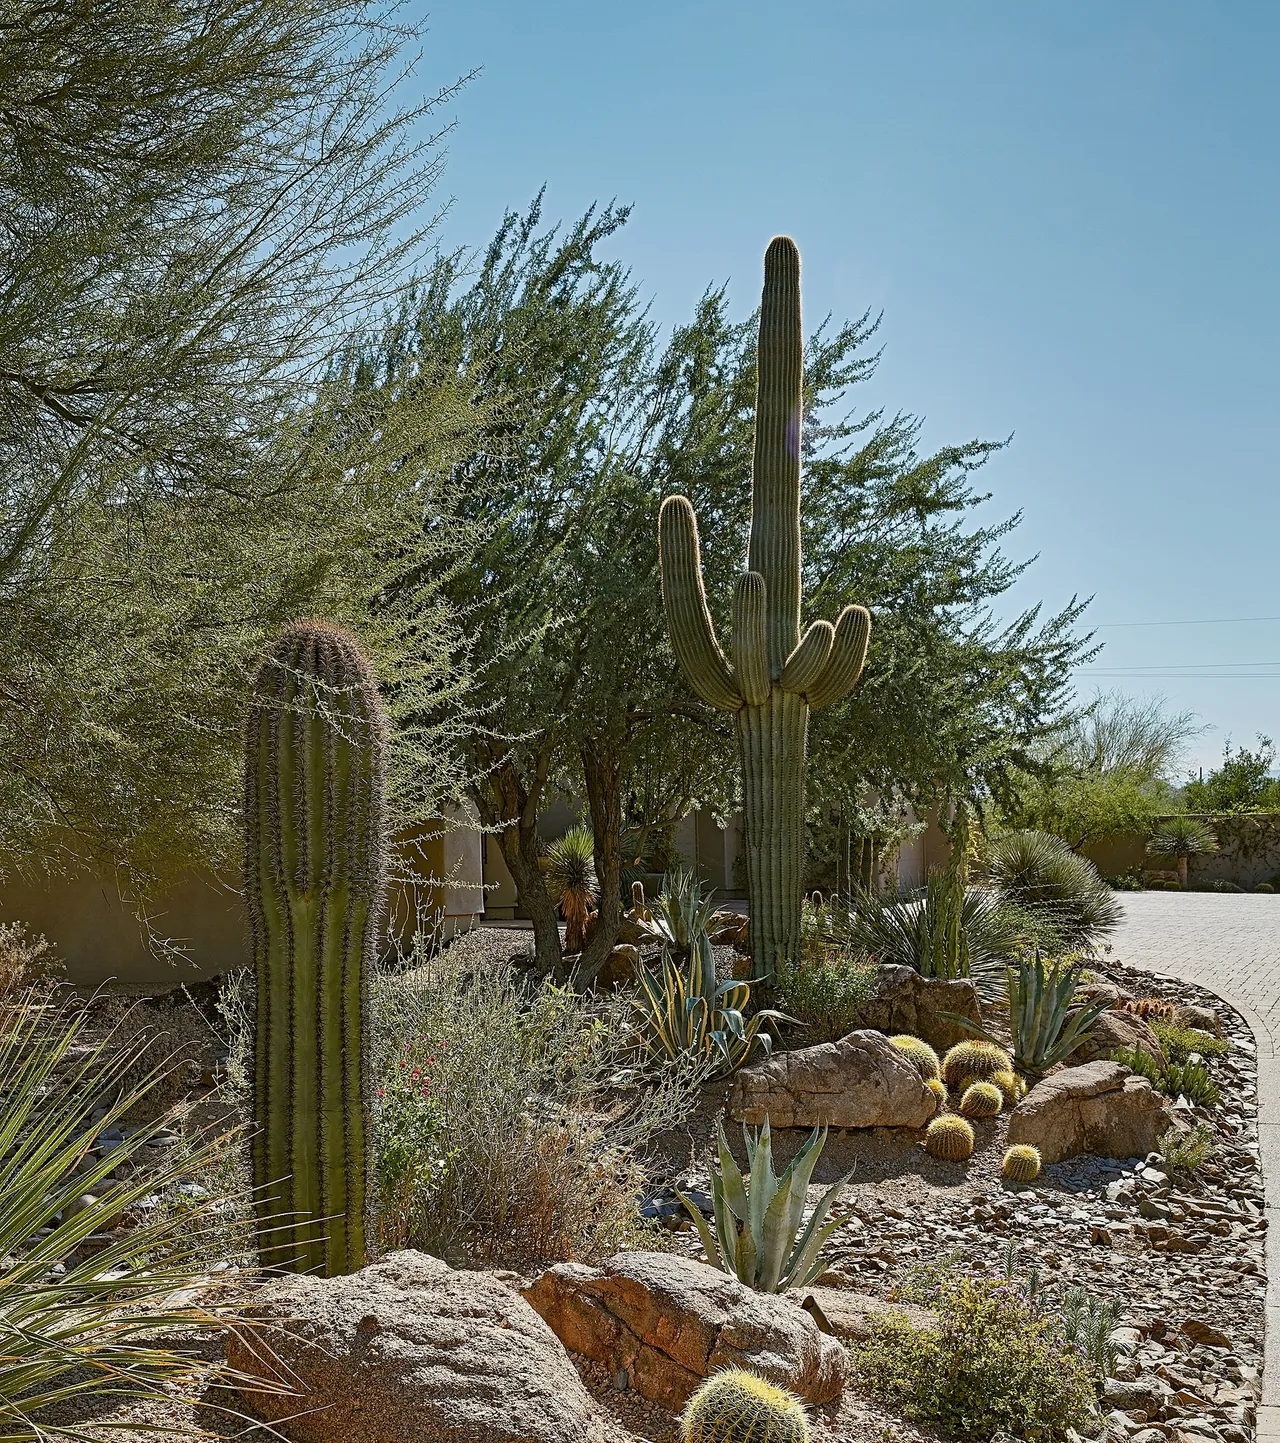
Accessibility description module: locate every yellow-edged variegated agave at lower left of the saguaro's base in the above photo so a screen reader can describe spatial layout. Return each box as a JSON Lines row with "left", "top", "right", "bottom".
{"left": 634, "top": 952, "right": 794, "bottom": 1076}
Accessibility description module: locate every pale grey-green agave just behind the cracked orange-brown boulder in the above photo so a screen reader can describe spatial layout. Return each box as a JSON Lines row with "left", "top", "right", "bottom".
{"left": 680, "top": 1118, "right": 849, "bottom": 1293}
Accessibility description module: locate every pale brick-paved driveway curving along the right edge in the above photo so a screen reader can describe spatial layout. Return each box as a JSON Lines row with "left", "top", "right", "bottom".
{"left": 1113, "top": 892, "right": 1280, "bottom": 1443}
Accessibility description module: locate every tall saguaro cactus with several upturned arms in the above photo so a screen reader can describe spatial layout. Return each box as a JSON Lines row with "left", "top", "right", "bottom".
{"left": 658, "top": 235, "right": 872, "bottom": 974}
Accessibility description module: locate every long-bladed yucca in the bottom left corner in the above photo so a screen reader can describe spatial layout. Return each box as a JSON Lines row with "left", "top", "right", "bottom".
{"left": 0, "top": 993, "right": 278, "bottom": 1440}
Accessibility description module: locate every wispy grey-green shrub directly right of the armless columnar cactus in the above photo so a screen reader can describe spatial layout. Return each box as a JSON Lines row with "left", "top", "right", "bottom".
{"left": 377, "top": 947, "right": 700, "bottom": 1263}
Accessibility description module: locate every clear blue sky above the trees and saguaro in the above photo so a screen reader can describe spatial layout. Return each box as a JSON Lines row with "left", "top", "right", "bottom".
{"left": 420, "top": 0, "right": 1280, "bottom": 766}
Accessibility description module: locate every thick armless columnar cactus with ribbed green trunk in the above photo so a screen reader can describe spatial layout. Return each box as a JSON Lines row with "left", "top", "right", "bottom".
{"left": 244, "top": 622, "right": 387, "bottom": 1277}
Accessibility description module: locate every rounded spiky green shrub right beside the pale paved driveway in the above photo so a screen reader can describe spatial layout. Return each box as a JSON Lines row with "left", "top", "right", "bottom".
{"left": 987, "top": 831, "right": 1120, "bottom": 949}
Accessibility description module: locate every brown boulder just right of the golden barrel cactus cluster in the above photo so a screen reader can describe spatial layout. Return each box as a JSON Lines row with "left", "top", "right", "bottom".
{"left": 1009, "top": 1062, "right": 1173, "bottom": 1163}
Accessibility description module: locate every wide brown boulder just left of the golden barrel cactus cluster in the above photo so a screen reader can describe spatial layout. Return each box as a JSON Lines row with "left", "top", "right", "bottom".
{"left": 729, "top": 1030, "right": 938, "bottom": 1127}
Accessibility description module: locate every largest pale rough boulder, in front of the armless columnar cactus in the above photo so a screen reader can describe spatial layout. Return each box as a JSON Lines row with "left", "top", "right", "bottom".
{"left": 228, "top": 1253, "right": 603, "bottom": 1443}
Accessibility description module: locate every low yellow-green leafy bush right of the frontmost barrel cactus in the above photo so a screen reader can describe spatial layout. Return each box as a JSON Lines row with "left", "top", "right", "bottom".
{"left": 853, "top": 1274, "right": 1095, "bottom": 1443}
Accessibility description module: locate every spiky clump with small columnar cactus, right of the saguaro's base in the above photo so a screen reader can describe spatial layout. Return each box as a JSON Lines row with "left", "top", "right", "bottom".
{"left": 849, "top": 874, "right": 1014, "bottom": 999}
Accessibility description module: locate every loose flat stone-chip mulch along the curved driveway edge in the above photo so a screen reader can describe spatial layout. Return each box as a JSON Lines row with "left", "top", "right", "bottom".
{"left": 655, "top": 961, "right": 1266, "bottom": 1443}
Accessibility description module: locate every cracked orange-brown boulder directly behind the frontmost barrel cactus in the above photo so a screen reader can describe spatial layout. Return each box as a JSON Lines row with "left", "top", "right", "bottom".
{"left": 524, "top": 1253, "right": 847, "bottom": 1411}
